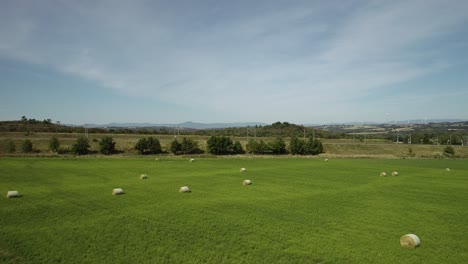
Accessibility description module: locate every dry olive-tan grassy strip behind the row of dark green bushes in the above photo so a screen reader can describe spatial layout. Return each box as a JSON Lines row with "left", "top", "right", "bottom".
{"left": 0, "top": 132, "right": 468, "bottom": 158}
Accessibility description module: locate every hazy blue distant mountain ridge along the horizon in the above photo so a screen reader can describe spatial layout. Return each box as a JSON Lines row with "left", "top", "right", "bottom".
{"left": 78, "top": 121, "right": 267, "bottom": 129}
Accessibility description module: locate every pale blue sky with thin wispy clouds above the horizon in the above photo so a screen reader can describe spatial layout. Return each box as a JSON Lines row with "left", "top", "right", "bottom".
{"left": 0, "top": 0, "right": 468, "bottom": 124}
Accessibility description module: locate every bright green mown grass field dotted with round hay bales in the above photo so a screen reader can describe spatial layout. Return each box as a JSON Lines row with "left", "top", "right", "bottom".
{"left": 0, "top": 157, "right": 468, "bottom": 263}
